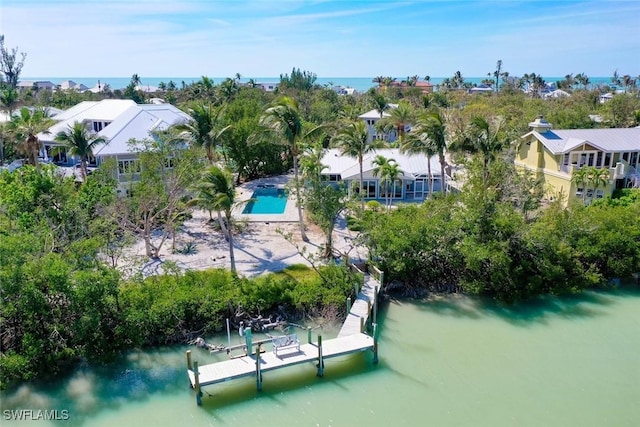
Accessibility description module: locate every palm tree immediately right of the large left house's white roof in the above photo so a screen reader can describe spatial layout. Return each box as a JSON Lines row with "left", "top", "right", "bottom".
{"left": 176, "top": 104, "right": 231, "bottom": 164}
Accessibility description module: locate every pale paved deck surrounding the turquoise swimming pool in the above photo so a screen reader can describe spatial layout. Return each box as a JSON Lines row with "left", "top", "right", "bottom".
{"left": 233, "top": 175, "right": 298, "bottom": 223}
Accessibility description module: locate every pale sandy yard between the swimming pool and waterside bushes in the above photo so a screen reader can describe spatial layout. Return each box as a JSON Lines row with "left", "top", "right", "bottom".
{"left": 119, "top": 176, "right": 366, "bottom": 276}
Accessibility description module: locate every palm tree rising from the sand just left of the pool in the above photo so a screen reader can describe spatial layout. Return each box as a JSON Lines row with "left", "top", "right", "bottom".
{"left": 192, "top": 165, "right": 237, "bottom": 273}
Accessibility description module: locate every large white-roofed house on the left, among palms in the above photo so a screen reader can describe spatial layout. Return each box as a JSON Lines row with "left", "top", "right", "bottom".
{"left": 38, "top": 99, "right": 190, "bottom": 189}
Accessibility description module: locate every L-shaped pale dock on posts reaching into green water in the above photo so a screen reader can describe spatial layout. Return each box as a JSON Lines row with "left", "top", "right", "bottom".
{"left": 187, "top": 271, "right": 384, "bottom": 405}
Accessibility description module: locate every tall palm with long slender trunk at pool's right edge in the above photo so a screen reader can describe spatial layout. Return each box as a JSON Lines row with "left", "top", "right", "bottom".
{"left": 260, "top": 96, "right": 309, "bottom": 242}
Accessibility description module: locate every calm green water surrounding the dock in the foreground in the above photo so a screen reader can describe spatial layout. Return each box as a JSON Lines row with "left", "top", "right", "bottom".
{"left": 0, "top": 287, "right": 640, "bottom": 427}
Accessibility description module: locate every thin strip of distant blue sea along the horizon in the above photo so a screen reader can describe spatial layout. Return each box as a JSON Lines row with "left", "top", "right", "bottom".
{"left": 21, "top": 76, "right": 611, "bottom": 92}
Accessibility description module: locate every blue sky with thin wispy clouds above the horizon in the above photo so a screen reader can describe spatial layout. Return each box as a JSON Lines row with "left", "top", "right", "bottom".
{"left": 0, "top": 0, "right": 640, "bottom": 77}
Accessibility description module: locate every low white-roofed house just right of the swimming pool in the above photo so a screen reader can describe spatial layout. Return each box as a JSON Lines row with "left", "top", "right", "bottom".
{"left": 322, "top": 148, "right": 442, "bottom": 202}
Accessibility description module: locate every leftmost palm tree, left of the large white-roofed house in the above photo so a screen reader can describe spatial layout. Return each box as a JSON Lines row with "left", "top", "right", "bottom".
{"left": 7, "top": 107, "right": 53, "bottom": 171}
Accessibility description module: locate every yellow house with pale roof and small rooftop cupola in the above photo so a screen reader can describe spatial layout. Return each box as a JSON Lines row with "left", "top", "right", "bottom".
{"left": 514, "top": 116, "right": 640, "bottom": 203}
